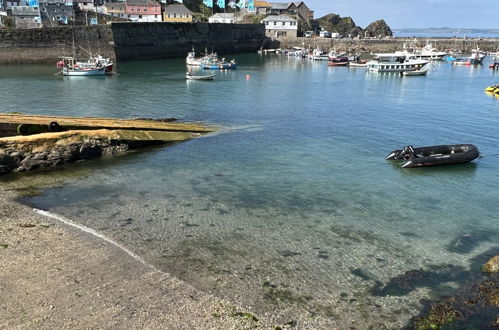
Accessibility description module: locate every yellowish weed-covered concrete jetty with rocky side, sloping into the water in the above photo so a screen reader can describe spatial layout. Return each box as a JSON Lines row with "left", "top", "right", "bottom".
{"left": 0, "top": 114, "right": 216, "bottom": 175}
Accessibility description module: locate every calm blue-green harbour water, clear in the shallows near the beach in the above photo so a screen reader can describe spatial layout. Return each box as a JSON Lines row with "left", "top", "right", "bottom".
{"left": 0, "top": 54, "right": 499, "bottom": 329}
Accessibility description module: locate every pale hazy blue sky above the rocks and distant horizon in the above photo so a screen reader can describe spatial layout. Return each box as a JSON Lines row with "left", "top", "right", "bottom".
{"left": 308, "top": 0, "right": 499, "bottom": 28}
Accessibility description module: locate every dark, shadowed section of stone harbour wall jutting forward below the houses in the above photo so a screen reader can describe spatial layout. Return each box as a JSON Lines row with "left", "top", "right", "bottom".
{"left": 112, "top": 23, "right": 266, "bottom": 60}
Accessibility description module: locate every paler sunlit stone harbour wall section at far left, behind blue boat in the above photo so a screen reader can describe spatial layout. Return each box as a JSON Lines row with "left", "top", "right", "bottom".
{"left": 0, "top": 25, "right": 115, "bottom": 64}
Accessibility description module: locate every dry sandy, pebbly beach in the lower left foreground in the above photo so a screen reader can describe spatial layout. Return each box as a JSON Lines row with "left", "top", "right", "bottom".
{"left": 0, "top": 188, "right": 273, "bottom": 329}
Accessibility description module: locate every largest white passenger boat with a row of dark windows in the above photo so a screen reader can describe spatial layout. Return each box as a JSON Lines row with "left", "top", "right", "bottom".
{"left": 367, "top": 52, "right": 430, "bottom": 73}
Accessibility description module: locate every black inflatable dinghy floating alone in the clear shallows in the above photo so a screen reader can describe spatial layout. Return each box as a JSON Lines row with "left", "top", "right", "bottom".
{"left": 385, "top": 144, "right": 480, "bottom": 168}
